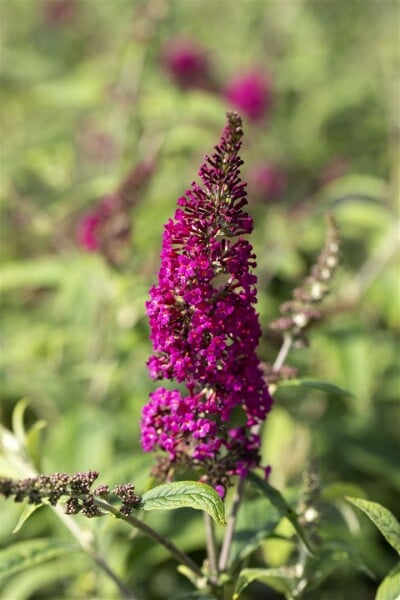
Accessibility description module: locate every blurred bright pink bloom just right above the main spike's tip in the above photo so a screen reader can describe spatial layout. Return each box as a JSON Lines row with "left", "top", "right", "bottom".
{"left": 223, "top": 70, "right": 271, "bottom": 121}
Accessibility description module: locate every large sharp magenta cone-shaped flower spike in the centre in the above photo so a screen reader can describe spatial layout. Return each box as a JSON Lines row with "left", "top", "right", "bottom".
{"left": 141, "top": 112, "right": 272, "bottom": 491}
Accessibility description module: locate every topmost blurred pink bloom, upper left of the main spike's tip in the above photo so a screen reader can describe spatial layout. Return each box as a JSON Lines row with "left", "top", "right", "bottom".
{"left": 162, "top": 38, "right": 211, "bottom": 89}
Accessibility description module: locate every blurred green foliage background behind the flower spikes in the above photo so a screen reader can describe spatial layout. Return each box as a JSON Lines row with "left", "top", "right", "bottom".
{"left": 0, "top": 0, "right": 400, "bottom": 600}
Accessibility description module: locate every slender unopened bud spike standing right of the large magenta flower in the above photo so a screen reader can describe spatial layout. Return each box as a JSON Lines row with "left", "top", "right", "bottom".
{"left": 270, "top": 215, "right": 340, "bottom": 345}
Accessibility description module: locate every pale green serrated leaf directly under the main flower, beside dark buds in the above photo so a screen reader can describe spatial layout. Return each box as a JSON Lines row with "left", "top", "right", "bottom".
{"left": 139, "top": 481, "right": 225, "bottom": 525}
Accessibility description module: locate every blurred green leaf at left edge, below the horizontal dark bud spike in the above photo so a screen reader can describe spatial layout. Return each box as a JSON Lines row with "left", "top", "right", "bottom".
{"left": 0, "top": 539, "right": 79, "bottom": 580}
